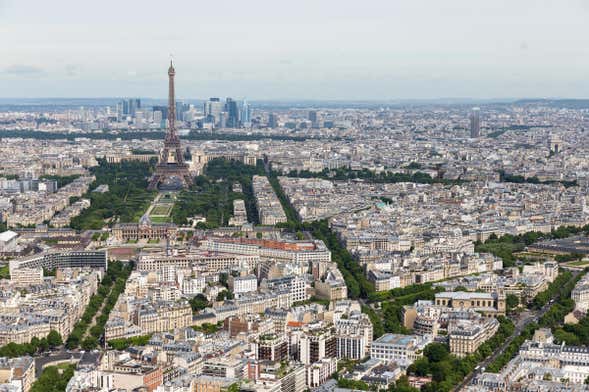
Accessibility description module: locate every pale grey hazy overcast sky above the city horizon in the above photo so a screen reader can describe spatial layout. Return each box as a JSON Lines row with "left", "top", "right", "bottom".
{"left": 0, "top": 0, "right": 589, "bottom": 100}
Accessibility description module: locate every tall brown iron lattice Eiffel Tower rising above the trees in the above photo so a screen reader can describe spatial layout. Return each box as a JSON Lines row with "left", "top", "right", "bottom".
{"left": 147, "top": 61, "right": 192, "bottom": 190}
